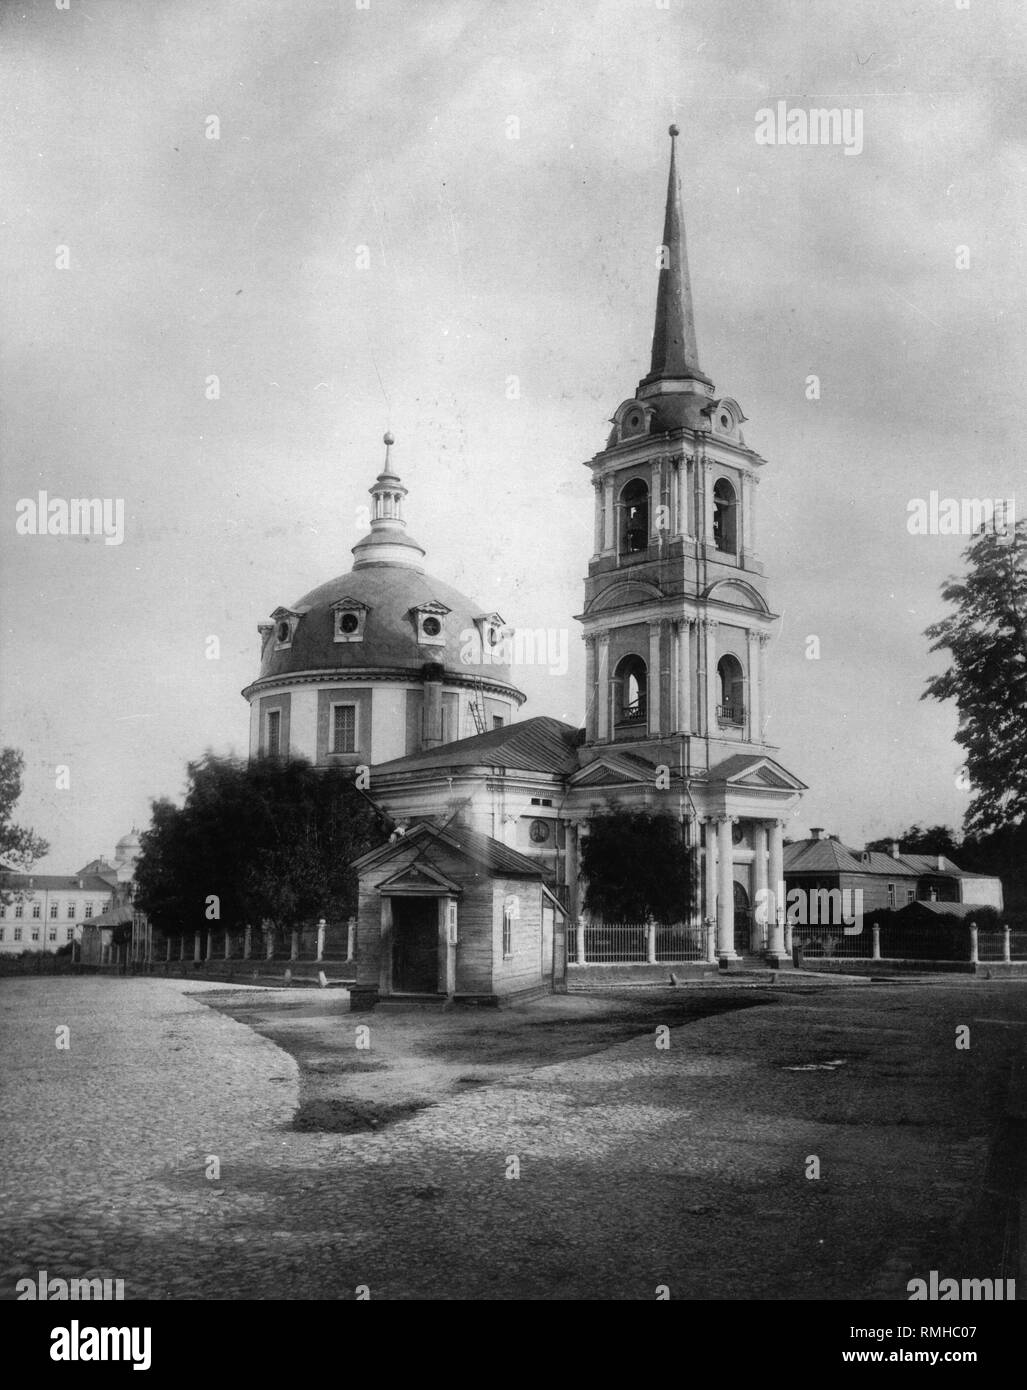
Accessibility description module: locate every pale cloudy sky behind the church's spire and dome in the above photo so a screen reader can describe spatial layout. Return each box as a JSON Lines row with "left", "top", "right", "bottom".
{"left": 0, "top": 0, "right": 1027, "bottom": 872}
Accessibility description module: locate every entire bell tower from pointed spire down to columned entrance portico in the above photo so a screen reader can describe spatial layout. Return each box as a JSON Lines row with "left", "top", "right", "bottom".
{"left": 566, "top": 125, "right": 805, "bottom": 966}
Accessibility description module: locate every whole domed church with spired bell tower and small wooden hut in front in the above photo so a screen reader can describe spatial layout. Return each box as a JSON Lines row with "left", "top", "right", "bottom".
{"left": 243, "top": 126, "right": 805, "bottom": 999}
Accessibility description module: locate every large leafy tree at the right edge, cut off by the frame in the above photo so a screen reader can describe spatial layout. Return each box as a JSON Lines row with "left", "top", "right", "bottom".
{"left": 921, "top": 521, "right": 1027, "bottom": 834}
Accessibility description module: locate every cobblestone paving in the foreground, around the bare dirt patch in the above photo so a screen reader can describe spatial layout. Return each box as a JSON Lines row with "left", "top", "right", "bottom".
{"left": 0, "top": 977, "right": 1026, "bottom": 1298}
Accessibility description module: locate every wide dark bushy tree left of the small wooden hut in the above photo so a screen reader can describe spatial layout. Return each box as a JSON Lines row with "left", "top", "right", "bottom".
{"left": 135, "top": 755, "right": 389, "bottom": 934}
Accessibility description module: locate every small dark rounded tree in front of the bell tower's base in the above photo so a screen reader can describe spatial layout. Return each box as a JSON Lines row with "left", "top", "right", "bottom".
{"left": 581, "top": 810, "right": 693, "bottom": 923}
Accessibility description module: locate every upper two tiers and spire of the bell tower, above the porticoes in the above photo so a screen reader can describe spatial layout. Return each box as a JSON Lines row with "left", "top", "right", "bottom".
{"left": 581, "top": 125, "right": 775, "bottom": 771}
